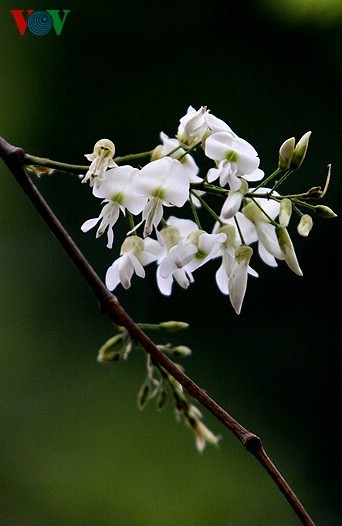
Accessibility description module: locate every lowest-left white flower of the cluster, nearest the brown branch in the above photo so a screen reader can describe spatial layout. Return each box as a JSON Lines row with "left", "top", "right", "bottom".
{"left": 106, "top": 236, "right": 162, "bottom": 290}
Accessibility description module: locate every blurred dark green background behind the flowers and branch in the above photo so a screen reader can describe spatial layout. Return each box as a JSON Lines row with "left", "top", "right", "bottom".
{"left": 0, "top": 0, "right": 342, "bottom": 526}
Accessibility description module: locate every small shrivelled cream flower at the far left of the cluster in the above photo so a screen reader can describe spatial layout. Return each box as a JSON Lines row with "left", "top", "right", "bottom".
{"left": 82, "top": 139, "right": 117, "bottom": 186}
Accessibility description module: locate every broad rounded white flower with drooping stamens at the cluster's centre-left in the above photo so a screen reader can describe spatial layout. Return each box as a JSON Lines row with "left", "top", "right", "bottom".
{"left": 136, "top": 157, "right": 190, "bottom": 236}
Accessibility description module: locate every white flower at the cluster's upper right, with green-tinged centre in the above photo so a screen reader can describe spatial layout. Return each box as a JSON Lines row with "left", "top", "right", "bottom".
{"left": 205, "top": 132, "right": 264, "bottom": 191}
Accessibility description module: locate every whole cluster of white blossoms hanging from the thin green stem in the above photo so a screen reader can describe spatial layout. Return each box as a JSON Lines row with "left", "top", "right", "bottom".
{"left": 82, "top": 106, "right": 307, "bottom": 314}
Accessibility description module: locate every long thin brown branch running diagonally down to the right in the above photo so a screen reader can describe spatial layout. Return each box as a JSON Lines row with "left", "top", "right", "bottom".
{"left": 0, "top": 137, "right": 315, "bottom": 526}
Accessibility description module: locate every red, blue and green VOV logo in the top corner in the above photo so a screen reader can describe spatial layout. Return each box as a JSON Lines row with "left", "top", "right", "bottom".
{"left": 10, "top": 9, "right": 70, "bottom": 36}
